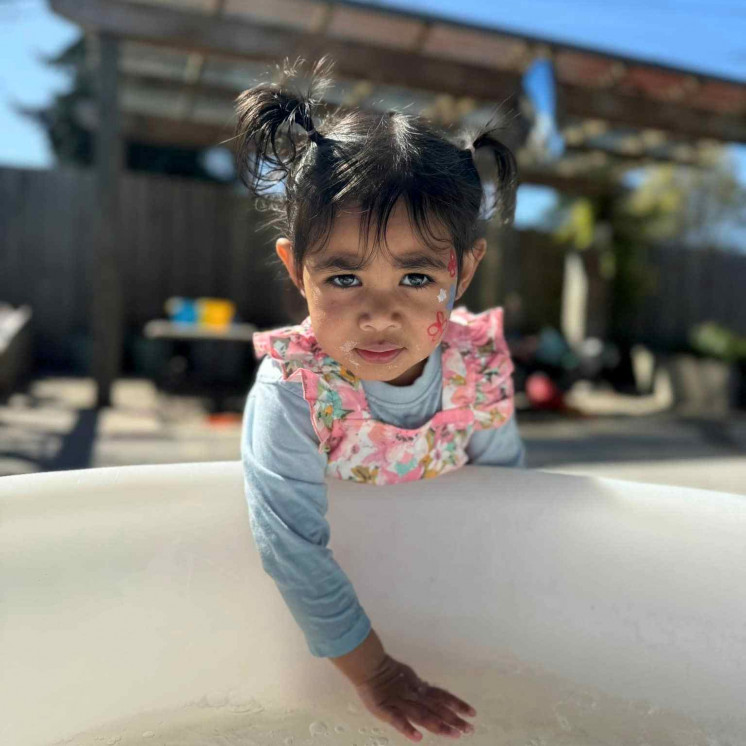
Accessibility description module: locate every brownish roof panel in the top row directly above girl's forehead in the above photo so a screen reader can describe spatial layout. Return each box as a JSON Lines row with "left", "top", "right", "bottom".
{"left": 326, "top": 5, "right": 424, "bottom": 49}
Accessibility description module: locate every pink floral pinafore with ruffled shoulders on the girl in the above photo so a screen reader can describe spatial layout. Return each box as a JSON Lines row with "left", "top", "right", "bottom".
{"left": 253, "top": 306, "right": 514, "bottom": 485}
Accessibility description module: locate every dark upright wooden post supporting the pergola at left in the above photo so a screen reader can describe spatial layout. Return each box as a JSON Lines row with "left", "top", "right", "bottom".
{"left": 91, "top": 34, "right": 123, "bottom": 408}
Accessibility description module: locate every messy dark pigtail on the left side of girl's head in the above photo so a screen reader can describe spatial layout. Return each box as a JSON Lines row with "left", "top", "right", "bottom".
{"left": 234, "top": 58, "right": 330, "bottom": 194}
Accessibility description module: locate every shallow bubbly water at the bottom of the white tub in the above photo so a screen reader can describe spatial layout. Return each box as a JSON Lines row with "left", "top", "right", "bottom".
{"left": 49, "top": 659, "right": 746, "bottom": 746}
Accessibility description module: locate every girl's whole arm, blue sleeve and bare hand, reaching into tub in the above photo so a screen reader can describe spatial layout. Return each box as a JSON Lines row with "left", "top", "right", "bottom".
{"left": 241, "top": 366, "right": 475, "bottom": 741}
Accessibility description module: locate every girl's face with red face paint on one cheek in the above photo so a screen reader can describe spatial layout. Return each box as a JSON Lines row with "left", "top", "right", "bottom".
{"left": 277, "top": 202, "right": 485, "bottom": 386}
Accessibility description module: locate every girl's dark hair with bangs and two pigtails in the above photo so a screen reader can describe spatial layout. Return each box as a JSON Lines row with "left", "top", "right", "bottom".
{"left": 234, "top": 58, "right": 517, "bottom": 275}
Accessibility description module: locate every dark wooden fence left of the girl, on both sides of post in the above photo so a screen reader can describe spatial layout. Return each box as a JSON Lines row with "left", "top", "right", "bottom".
{"left": 0, "top": 168, "right": 294, "bottom": 367}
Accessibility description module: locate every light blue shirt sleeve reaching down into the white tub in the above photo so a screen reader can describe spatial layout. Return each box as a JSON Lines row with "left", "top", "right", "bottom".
{"left": 241, "top": 367, "right": 371, "bottom": 657}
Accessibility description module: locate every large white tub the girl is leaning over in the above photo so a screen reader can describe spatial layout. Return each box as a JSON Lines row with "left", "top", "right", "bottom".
{"left": 0, "top": 462, "right": 746, "bottom": 746}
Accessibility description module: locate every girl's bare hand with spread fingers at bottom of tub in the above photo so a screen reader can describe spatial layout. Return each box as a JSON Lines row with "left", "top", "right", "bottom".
{"left": 355, "top": 655, "right": 477, "bottom": 741}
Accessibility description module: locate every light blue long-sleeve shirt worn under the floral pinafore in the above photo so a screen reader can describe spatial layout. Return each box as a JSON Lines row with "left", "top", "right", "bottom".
{"left": 241, "top": 347, "right": 525, "bottom": 657}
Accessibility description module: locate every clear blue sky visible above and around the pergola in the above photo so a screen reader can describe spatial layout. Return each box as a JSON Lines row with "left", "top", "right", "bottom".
{"left": 0, "top": 0, "right": 746, "bottom": 226}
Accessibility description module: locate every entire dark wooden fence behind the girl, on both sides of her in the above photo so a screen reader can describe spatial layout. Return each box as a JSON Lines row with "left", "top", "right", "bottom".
{"left": 0, "top": 167, "right": 746, "bottom": 372}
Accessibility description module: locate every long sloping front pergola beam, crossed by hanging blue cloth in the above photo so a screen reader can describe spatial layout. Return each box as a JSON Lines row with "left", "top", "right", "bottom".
{"left": 51, "top": 0, "right": 746, "bottom": 142}
